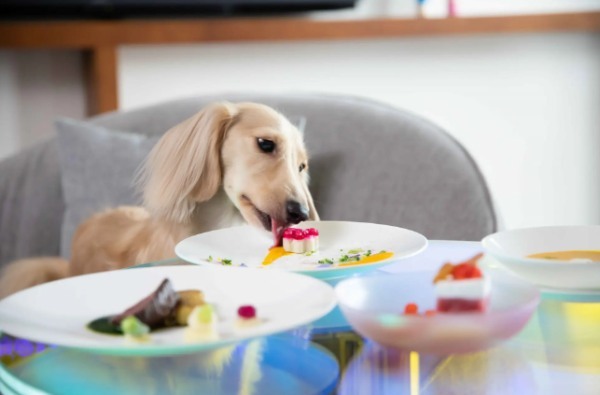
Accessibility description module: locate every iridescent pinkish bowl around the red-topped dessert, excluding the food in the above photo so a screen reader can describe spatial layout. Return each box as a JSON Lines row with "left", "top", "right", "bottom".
{"left": 335, "top": 243, "right": 539, "bottom": 355}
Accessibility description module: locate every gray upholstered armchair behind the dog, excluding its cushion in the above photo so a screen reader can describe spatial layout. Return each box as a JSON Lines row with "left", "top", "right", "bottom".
{"left": 0, "top": 94, "right": 497, "bottom": 267}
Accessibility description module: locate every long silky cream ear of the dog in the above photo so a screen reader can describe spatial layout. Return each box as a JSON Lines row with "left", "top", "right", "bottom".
{"left": 138, "top": 103, "right": 238, "bottom": 223}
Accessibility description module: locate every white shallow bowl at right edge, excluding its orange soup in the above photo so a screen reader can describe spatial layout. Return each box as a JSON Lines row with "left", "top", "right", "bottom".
{"left": 482, "top": 226, "right": 600, "bottom": 291}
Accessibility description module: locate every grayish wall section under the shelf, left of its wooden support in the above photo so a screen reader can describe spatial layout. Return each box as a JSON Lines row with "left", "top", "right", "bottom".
{"left": 0, "top": 50, "right": 86, "bottom": 159}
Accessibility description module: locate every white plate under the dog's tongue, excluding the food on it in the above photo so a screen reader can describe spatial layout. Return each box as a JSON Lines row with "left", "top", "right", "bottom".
{"left": 175, "top": 221, "right": 427, "bottom": 279}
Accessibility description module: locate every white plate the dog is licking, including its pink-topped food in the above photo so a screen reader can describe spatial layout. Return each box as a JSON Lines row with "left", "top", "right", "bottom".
{"left": 175, "top": 221, "right": 427, "bottom": 279}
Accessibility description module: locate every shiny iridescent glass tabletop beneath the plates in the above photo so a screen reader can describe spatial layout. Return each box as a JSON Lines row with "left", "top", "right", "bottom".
{"left": 0, "top": 241, "right": 600, "bottom": 395}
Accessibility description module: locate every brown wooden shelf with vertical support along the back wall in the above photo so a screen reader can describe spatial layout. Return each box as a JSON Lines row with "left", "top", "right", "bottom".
{"left": 0, "top": 12, "right": 600, "bottom": 115}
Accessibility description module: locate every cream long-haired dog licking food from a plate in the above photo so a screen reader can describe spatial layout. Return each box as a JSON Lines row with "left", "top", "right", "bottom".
{"left": 0, "top": 102, "right": 319, "bottom": 297}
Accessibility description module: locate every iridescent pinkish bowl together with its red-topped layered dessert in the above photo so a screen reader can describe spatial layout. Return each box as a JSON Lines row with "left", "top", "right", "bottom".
{"left": 335, "top": 254, "right": 539, "bottom": 355}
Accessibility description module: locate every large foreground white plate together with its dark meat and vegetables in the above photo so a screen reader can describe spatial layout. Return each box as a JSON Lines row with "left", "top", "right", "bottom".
{"left": 0, "top": 266, "right": 335, "bottom": 356}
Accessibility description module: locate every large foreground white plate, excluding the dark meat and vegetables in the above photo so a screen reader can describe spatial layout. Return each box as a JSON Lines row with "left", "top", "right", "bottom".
{"left": 0, "top": 266, "right": 335, "bottom": 356}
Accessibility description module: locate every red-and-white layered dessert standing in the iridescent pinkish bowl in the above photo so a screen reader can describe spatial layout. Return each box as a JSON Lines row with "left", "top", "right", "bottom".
{"left": 433, "top": 254, "right": 490, "bottom": 313}
